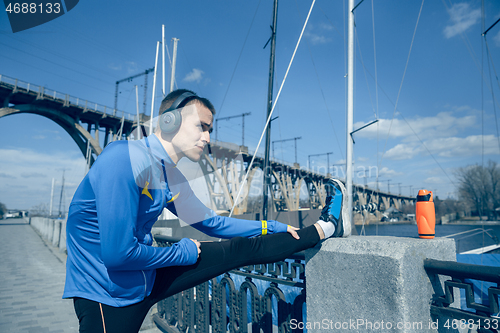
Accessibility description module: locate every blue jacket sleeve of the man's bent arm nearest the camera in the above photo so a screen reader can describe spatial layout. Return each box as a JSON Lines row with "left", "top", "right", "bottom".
{"left": 89, "top": 144, "right": 198, "bottom": 270}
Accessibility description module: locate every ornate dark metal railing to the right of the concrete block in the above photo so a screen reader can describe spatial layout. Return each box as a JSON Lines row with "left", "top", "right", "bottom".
{"left": 424, "top": 259, "right": 500, "bottom": 332}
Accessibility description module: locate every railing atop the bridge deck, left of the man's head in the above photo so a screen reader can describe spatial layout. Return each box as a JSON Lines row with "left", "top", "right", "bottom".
{"left": 0, "top": 74, "right": 137, "bottom": 121}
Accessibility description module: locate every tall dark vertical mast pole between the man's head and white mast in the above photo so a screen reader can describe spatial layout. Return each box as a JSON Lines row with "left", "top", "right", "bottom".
{"left": 262, "top": 0, "right": 278, "bottom": 220}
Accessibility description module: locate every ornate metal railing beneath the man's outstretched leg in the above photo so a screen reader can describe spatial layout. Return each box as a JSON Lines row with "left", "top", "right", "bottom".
{"left": 153, "top": 235, "right": 306, "bottom": 333}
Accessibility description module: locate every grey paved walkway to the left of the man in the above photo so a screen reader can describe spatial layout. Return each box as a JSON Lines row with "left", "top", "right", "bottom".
{"left": 0, "top": 219, "right": 78, "bottom": 333}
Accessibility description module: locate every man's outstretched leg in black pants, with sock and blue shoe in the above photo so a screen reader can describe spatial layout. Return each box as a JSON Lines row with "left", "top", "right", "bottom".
{"left": 152, "top": 179, "right": 351, "bottom": 302}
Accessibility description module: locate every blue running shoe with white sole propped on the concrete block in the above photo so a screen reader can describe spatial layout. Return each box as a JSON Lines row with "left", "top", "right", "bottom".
{"left": 319, "top": 178, "right": 351, "bottom": 237}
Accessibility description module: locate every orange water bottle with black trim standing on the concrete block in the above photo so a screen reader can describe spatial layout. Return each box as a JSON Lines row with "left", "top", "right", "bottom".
{"left": 415, "top": 190, "right": 436, "bottom": 239}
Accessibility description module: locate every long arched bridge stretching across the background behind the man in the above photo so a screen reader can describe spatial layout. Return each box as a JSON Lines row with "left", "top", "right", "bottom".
{"left": 0, "top": 74, "right": 415, "bottom": 218}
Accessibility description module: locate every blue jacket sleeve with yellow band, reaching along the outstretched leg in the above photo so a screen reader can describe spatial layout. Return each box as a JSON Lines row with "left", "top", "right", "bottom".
{"left": 171, "top": 172, "right": 287, "bottom": 238}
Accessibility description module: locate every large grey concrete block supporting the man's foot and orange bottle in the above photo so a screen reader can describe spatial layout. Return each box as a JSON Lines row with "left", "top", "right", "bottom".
{"left": 306, "top": 236, "right": 456, "bottom": 332}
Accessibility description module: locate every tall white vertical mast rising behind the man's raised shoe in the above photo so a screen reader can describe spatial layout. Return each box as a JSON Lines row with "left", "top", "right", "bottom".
{"left": 346, "top": 0, "right": 354, "bottom": 221}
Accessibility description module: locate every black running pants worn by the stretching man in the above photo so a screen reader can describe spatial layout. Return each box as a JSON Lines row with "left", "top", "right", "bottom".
{"left": 74, "top": 225, "right": 320, "bottom": 333}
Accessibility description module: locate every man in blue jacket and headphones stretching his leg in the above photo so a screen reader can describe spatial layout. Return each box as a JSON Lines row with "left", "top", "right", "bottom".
{"left": 63, "top": 90, "right": 351, "bottom": 333}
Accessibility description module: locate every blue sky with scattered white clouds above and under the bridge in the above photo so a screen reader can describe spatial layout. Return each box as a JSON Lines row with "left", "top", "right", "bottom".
{"left": 0, "top": 0, "right": 500, "bottom": 209}
